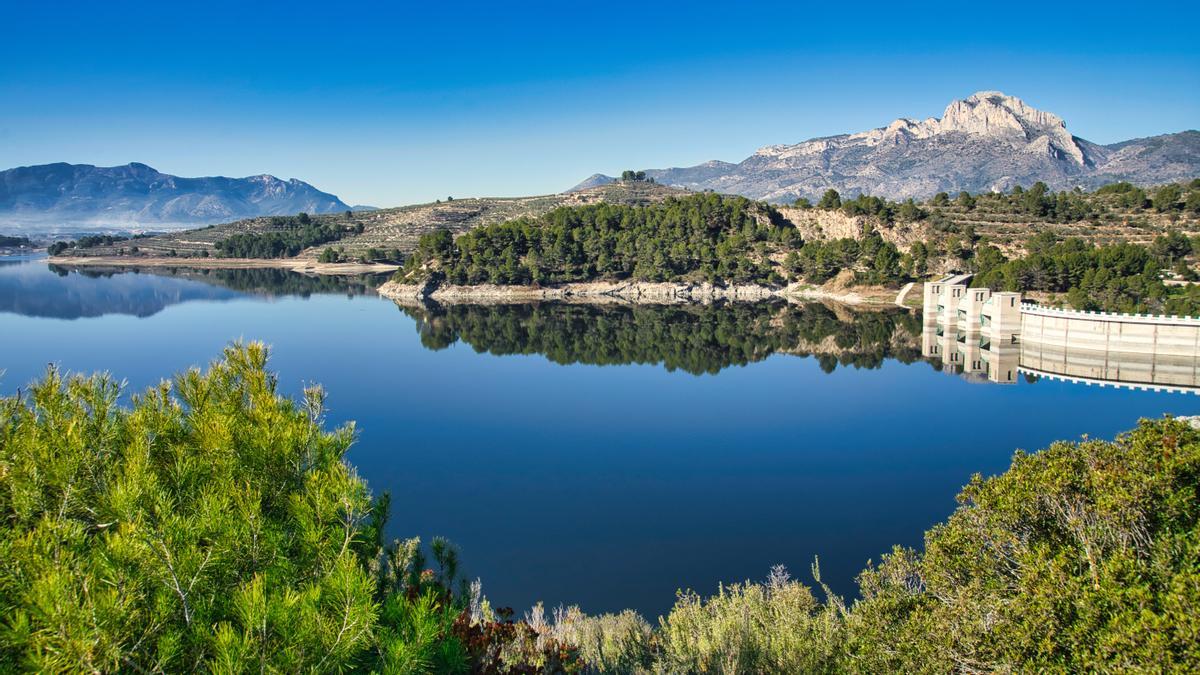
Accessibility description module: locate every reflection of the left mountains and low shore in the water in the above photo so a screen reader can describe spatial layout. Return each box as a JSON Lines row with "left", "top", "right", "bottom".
{"left": 0, "top": 258, "right": 373, "bottom": 319}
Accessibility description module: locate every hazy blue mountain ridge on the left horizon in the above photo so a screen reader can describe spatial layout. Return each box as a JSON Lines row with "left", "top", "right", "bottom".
{"left": 0, "top": 162, "right": 350, "bottom": 228}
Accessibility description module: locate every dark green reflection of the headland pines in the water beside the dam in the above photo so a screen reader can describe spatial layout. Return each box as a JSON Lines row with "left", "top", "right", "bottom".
{"left": 402, "top": 303, "right": 920, "bottom": 375}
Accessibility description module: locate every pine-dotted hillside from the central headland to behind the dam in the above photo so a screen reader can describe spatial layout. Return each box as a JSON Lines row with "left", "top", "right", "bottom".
{"left": 395, "top": 181, "right": 1200, "bottom": 315}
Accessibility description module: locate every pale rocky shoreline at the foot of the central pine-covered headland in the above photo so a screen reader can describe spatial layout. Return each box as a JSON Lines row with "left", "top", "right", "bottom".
{"left": 376, "top": 281, "right": 895, "bottom": 306}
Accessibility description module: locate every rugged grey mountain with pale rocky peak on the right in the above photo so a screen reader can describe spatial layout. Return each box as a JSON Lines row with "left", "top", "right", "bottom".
{"left": 575, "top": 91, "right": 1200, "bottom": 202}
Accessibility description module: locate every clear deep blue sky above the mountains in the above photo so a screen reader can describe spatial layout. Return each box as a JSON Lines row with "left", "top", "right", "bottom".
{"left": 0, "top": 0, "right": 1200, "bottom": 205}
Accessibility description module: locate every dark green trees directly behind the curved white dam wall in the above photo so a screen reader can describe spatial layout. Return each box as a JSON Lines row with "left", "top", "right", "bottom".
{"left": 972, "top": 232, "right": 1200, "bottom": 315}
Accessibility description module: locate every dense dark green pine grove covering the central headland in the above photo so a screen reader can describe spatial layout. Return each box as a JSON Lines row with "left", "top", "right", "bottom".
{"left": 401, "top": 193, "right": 800, "bottom": 285}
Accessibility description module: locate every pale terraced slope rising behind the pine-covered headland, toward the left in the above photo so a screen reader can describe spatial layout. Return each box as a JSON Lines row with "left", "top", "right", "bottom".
{"left": 61, "top": 181, "right": 686, "bottom": 259}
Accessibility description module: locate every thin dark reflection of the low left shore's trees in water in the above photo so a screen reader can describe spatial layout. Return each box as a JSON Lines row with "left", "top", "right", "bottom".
{"left": 49, "top": 264, "right": 386, "bottom": 298}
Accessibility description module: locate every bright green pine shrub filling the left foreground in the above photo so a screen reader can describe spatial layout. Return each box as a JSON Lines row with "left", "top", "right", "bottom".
{"left": 0, "top": 345, "right": 466, "bottom": 671}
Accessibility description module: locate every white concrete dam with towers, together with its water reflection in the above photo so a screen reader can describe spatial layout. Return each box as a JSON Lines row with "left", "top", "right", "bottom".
{"left": 922, "top": 275, "right": 1200, "bottom": 393}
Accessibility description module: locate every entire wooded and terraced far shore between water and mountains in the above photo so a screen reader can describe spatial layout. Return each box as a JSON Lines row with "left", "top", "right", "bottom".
{"left": 44, "top": 175, "right": 1200, "bottom": 315}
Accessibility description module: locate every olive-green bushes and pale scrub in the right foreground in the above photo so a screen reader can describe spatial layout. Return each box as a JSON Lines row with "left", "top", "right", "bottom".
{"left": 544, "top": 419, "right": 1200, "bottom": 673}
